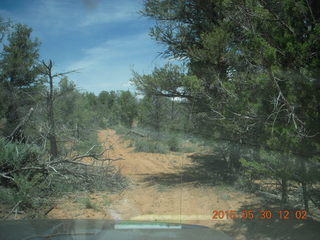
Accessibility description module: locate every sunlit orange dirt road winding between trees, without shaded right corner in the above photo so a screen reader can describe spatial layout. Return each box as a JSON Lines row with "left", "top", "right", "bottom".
{"left": 49, "top": 130, "right": 252, "bottom": 227}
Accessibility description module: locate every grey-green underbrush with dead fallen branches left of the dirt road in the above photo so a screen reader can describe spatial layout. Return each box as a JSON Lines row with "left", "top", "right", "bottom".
{"left": 0, "top": 137, "right": 127, "bottom": 218}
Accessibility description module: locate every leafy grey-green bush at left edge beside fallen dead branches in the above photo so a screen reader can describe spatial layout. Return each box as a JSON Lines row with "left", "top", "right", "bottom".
{"left": 0, "top": 138, "right": 48, "bottom": 209}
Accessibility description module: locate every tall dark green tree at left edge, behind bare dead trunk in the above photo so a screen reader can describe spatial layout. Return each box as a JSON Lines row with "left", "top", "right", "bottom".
{"left": 0, "top": 24, "right": 40, "bottom": 140}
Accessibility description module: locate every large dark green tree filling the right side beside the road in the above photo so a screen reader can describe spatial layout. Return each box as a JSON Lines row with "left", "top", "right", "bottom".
{"left": 140, "top": 0, "right": 320, "bottom": 208}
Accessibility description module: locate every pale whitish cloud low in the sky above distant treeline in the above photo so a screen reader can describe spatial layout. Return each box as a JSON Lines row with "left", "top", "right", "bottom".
{"left": 67, "top": 33, "right": 162, "bottom": 93}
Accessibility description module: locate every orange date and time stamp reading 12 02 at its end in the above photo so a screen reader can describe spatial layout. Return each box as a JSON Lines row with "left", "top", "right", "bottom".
{"left": 212, "top": 210, "right": 308, "bottom": 220}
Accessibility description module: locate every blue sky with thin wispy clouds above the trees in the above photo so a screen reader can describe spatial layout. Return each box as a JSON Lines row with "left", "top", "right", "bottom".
{"left": 0, "top": 0, "right": 169, "bottom": 94}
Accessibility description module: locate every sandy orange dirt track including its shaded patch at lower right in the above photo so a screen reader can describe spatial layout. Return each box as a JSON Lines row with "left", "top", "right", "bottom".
{"left": 48, "top": 130, "right": 319, "bottom": 240}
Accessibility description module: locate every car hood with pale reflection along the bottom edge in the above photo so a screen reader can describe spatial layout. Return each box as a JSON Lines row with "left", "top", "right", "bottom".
{"left": 0, "top": 219, "right": 232, "bottom": 240}
